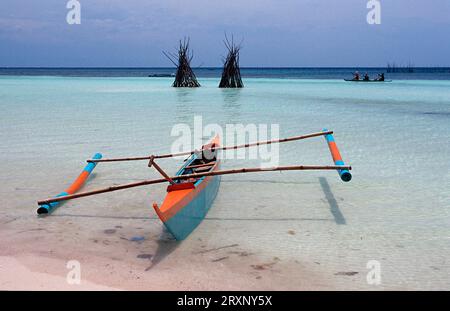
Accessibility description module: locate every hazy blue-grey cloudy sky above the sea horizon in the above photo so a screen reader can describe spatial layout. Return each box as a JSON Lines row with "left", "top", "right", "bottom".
{"left": 0, "top": 0, "right": 450, "bottom": 67}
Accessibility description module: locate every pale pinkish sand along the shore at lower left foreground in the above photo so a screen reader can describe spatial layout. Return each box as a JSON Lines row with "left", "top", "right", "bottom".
{"left": 0, "top": 188, "right": 333, "bottom": 290}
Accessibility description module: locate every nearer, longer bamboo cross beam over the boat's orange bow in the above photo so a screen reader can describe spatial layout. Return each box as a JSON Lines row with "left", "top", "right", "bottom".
{"left": 38, "top": 165, "right": 352, "bottom": 205}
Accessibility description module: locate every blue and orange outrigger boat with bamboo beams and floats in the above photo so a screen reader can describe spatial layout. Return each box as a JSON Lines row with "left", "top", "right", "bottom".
{"left": 38, "top": 130, "right": 352, "bottom": 240}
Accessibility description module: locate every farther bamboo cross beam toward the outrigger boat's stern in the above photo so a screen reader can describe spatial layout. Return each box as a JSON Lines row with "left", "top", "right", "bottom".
{"left": 87, "top": 131, "right": 333, "bottom": 163}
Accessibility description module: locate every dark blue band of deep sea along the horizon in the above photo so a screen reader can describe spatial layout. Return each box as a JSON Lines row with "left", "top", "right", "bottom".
{"left": 0, "top": 67, "right": 450, "bottom": 80}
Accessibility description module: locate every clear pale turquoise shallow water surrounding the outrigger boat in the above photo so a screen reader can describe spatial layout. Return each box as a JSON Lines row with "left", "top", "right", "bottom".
{"left": 0, "top": 77, "right": 450, "bottom": 288}
